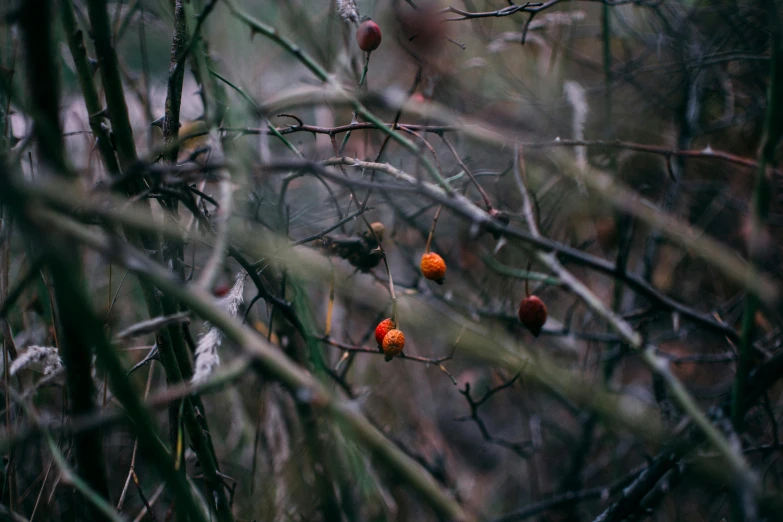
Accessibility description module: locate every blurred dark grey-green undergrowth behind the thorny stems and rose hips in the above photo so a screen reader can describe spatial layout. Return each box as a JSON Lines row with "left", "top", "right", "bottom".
{"left": 0, "top": 0, "right": 783, "bottom": 521}
